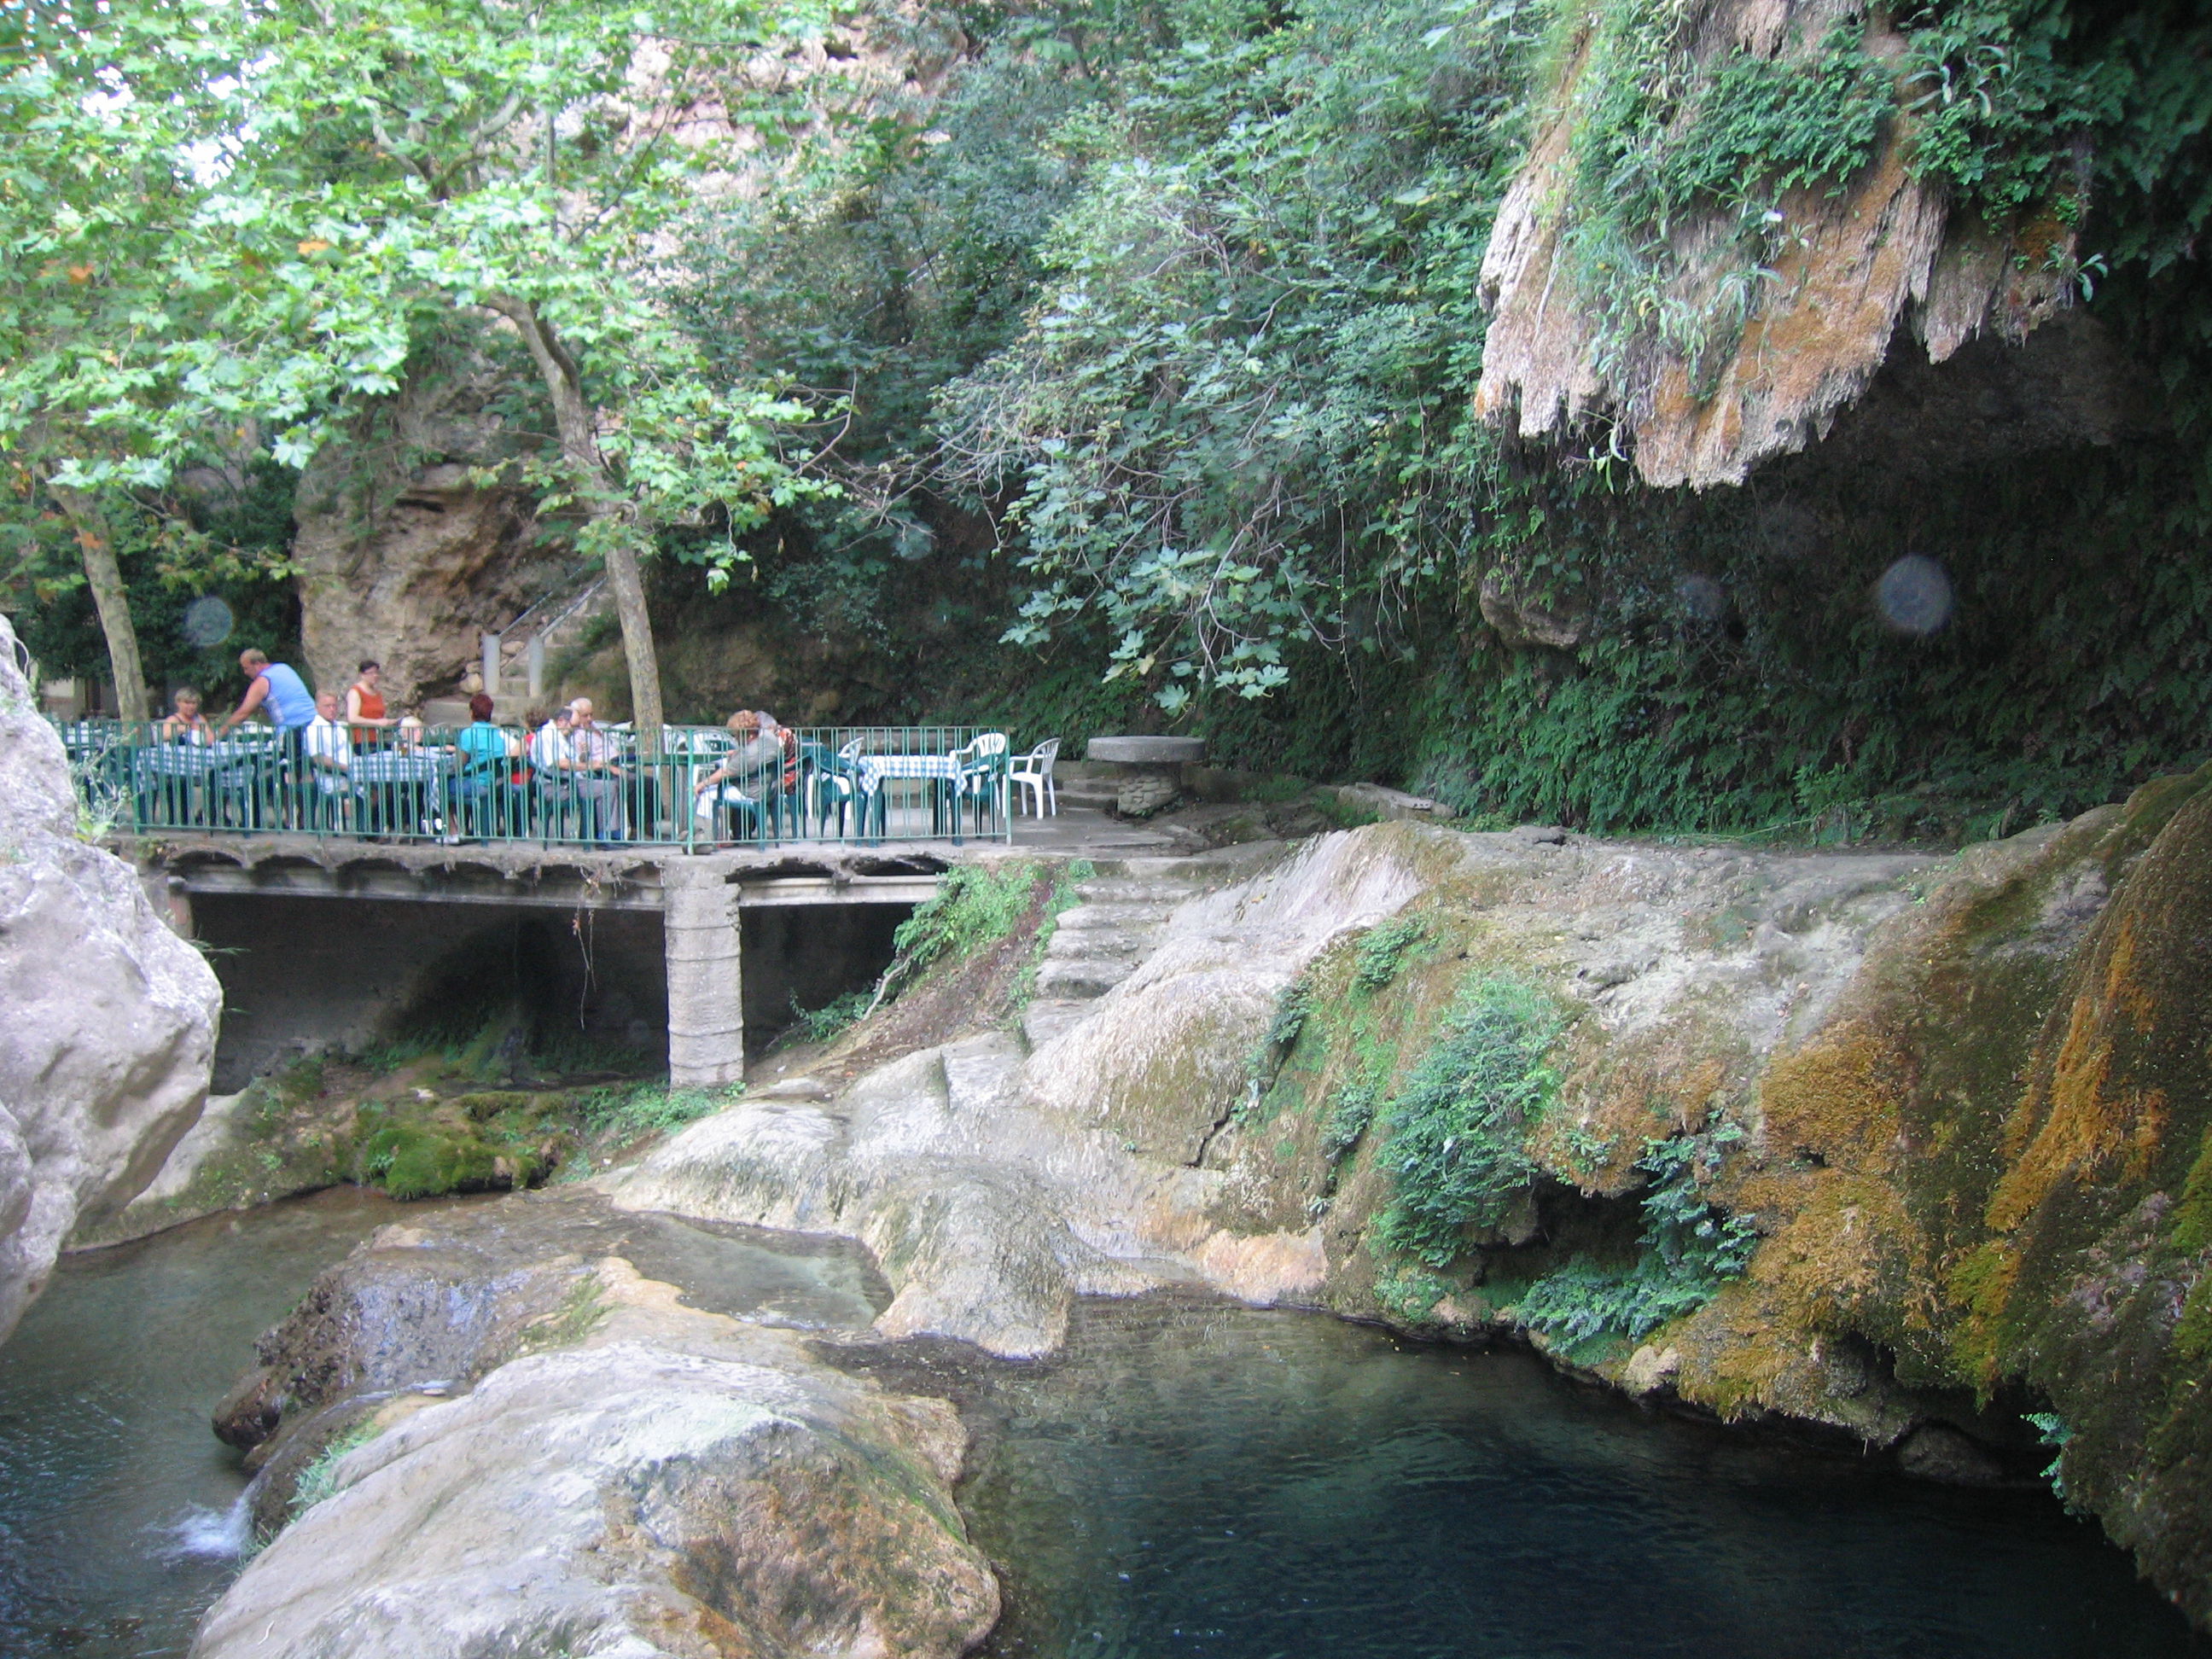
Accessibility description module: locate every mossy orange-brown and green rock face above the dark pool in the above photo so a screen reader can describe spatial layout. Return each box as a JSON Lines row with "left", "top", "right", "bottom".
{"left": 1152, "top": 774, "right": 2212, "bottom": 1621}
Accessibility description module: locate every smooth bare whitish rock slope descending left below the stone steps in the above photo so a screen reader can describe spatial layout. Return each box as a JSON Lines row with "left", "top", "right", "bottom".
{"left": 608, "top": 836, "right": 1417, "bottom": 1358}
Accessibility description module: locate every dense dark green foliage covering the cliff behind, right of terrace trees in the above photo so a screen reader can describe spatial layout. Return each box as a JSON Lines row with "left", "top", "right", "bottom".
{"left": 18, "top": 0, "right": 2212, "bottom": 838}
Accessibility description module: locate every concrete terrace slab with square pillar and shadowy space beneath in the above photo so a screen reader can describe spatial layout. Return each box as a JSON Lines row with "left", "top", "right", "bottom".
{"left": 126, "top": 836, "right": 964, "bottom": 1088}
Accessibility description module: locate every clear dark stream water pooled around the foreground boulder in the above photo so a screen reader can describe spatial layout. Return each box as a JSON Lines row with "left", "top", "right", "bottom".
{"left": 0, "top": 1190, "right": 2212, "bottom": 1659}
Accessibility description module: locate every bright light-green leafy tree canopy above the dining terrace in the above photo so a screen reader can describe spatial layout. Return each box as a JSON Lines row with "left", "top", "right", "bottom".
{"left": 0, "top": 0, "right": 821, "bottom": 719}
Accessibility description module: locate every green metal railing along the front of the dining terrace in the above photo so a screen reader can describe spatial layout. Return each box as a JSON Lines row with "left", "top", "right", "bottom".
{"left": 60, "top": 721, "right": 1013, "bottom": 852}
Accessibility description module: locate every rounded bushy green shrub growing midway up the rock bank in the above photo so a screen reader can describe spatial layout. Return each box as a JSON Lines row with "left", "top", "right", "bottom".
{"left": 1376, "top": 975, "right": 1562, "bottom": 1267}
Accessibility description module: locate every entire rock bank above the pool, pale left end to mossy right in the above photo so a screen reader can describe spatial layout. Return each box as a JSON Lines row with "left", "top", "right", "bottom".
{"left": 608, "top": 791, "right": 2212, "bottom": 1619}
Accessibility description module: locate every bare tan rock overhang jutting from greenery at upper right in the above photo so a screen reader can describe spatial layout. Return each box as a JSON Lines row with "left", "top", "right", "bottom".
{"left": 1476, "top": 0, "right": 2073, "bottom": 486}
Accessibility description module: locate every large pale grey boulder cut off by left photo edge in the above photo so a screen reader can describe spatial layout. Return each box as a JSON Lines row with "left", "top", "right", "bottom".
{"left": 0, "top": 620, "right": 221, "bottom": 1338}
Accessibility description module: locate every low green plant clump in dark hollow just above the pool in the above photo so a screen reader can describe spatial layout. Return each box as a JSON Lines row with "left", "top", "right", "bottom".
{"left": 1520, "top": 1126, "right": 1759, "bottom": 1345}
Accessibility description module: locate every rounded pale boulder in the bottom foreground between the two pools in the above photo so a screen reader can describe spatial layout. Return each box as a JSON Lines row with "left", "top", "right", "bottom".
{"left": 193, "top": 1217, "right": 998, "bottom": 1659}
